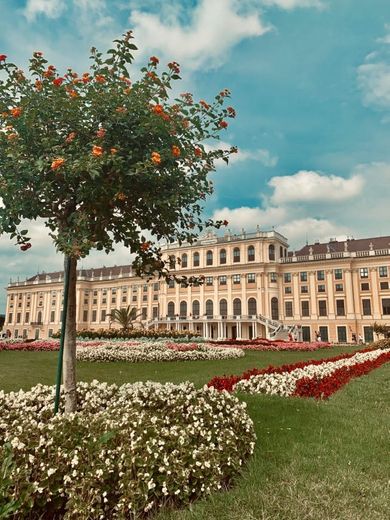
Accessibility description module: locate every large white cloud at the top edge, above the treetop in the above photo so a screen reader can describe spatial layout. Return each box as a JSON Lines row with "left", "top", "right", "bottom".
{"left": 130, "top": 0, "right": 270, "bottom": 69}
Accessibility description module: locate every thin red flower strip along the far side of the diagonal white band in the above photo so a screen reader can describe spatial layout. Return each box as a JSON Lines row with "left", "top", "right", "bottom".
{"left": 207, "top": 348, "right": 372, "bottom": 392}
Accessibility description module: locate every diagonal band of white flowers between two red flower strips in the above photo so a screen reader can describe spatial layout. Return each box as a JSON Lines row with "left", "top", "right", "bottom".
{"left": 234, "top": 349, "right": 390, "bottom": 397}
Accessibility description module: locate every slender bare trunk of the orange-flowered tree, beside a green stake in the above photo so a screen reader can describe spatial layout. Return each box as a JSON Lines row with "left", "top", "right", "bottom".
{"left": 63, "top": 257, "right": 77, "bottom": 413}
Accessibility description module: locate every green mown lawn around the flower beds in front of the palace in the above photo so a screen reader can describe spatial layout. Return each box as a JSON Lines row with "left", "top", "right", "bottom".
{"left": 0, "top": 347, "right": 390, "bottom": 520}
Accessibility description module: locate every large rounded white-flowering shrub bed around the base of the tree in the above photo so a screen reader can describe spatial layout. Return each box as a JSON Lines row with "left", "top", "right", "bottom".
{"left": 0, "top": 381, "right": 255, "bottom": 520}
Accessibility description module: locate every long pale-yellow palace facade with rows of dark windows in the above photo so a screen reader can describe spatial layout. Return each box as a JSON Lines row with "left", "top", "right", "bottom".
{"left": 4, "top": 228, "right": 390, "bottom": 342}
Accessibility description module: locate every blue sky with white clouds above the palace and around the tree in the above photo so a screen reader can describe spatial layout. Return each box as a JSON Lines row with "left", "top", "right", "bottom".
{"left": 0, "top": 0, "right": 390, "bottom": 313}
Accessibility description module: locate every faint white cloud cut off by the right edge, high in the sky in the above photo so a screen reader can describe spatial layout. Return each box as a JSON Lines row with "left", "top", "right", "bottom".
{"left": 357, "top": 62, "right": 390, "bottom": 108}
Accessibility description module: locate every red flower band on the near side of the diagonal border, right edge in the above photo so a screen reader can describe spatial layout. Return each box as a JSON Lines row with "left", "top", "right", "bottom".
{"left": 294, "top": 352, "right": 390, "bottom": 399}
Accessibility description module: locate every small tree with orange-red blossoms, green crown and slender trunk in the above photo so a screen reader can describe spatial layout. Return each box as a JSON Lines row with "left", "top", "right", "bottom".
{"left": 0, "top": 31, "right": 236, "bottom": 411}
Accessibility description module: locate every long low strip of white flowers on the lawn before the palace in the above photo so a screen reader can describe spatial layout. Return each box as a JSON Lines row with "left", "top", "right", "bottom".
{"left": 76, "top": 342, "right": 245, "bottom": 363}
